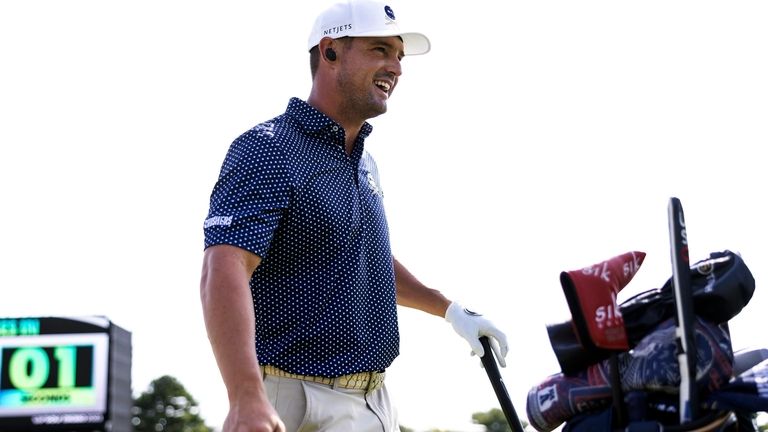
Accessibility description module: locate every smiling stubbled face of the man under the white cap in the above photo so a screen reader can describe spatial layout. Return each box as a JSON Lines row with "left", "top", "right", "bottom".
{"left": 336, "top": 36, "right": 404, "bottom": 120}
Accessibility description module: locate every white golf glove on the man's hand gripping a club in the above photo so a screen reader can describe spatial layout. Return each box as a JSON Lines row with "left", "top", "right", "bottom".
{"left": 445, "top": 302, "right": 509, "bottom": 367}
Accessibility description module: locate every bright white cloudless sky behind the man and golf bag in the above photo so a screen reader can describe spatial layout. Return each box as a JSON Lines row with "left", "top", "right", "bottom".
{"left": 0, "top": 0, "right": 768, "bottom": 432}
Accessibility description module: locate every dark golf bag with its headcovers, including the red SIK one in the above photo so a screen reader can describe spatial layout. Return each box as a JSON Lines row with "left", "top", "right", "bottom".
{"left": 526, "top": 250, "right": 768, "bottom": 432}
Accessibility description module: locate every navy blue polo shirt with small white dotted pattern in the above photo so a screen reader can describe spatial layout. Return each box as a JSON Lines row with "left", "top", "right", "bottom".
{"left": 204, "top": 98, "right": 399, "bottom": 377}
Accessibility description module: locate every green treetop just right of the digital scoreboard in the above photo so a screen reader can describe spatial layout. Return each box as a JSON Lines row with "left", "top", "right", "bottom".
{"left": 131, "top": 375, "right": 213, "bottom": 432}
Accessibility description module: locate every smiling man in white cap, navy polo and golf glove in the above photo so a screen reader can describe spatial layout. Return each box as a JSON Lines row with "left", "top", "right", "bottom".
{"left": 200, "top": 0, "right": 507, "bottom": 432}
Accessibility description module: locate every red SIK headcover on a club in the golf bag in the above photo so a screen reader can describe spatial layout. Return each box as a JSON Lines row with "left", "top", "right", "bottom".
{"left": 560, "top": 251, "right": 645, "bottom": 350}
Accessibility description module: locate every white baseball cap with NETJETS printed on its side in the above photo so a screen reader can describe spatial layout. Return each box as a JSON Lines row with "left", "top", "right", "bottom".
{"left": 307, "top": 0, "right": 430, "bottom": 55}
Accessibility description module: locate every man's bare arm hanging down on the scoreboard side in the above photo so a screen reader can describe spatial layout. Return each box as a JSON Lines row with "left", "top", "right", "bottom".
{"left": 200, "top": 245, "right": 284, "bottom": 432}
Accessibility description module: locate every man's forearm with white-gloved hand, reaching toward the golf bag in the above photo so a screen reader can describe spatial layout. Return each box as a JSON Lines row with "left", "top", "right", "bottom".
{"left": 392, "top": 257, "right": 509, "bottom": 367}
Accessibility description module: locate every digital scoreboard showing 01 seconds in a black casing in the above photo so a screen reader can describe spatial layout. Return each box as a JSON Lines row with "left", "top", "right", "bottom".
{"left": 0, "top": 317, "right": 133, "bottom": 432}
